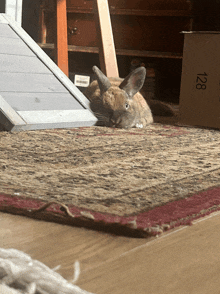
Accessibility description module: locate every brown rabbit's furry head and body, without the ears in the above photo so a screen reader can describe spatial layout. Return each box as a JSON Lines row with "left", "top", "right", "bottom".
{"left": 85, "top": 78, "right": 153, "bottom": 128}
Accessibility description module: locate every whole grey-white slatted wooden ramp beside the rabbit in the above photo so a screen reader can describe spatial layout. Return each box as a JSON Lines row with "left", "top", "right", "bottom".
{"left": 0, "top": 14, "right": 97, "bottom": 131}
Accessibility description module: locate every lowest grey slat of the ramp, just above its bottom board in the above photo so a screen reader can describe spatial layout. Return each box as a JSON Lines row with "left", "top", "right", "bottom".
{"left": 2, "top": 92, "right": 84, "bottom": 111}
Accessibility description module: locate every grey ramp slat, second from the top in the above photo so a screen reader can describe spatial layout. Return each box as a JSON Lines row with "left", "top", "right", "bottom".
{"left": 0, "top": 36, "right": 35, "bottom": 56}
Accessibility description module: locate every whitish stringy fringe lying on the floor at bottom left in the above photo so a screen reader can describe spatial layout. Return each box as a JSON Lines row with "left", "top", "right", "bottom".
{"left": 0, "top": 248, "right": 92, "bottom": 294}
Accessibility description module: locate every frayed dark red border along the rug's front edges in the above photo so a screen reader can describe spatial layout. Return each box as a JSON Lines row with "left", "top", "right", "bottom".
{"left": 0, "top": 186, "right": 220, "bottom": 238}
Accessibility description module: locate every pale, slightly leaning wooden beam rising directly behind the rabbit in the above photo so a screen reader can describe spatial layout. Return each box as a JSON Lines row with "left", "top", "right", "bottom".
{"left": 93, "top": 0, "right": 118, "bottom": 77}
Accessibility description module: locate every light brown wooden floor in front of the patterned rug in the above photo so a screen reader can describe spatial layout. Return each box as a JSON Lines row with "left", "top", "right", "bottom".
{"left": 0, "top": 213, "right": 220, "bottom": 294}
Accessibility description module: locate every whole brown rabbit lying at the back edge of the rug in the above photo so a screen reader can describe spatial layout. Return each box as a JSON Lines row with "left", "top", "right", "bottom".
{"left": 84, "top": 66, "right": 153, "bottom": 128}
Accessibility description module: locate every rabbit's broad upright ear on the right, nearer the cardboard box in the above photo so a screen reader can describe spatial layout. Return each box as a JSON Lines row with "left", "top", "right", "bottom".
{"left": 119, "top": 66, "right": 146, "bottom": 98}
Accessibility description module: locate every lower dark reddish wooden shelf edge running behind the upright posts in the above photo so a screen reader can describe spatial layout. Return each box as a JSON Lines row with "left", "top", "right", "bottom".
{"left": 38, "top": 43, "right": 182, "bottom": 59}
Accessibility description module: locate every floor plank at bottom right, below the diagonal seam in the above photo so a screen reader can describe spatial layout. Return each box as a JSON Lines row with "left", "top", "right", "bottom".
{"left": 78, "top": 213, "right": 220, "bottom": 294}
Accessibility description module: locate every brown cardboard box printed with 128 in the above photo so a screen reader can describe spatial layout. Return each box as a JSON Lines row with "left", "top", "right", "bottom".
{"left": 180, "top": 32, "right": 220, "bottom": 128}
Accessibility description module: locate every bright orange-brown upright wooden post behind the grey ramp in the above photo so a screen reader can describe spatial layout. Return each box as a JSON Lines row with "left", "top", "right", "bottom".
{"left": 56, "top": 0, "right": 69, "bottom": 76}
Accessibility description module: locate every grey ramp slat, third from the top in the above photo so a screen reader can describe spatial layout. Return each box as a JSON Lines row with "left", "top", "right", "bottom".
{"left": 0, "top": 53, "right": 51, "bottom": 74}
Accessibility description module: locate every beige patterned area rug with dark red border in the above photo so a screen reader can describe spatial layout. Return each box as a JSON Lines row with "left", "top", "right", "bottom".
{"left": 0, "top": 123, "right": 220, "bottom": 237}
